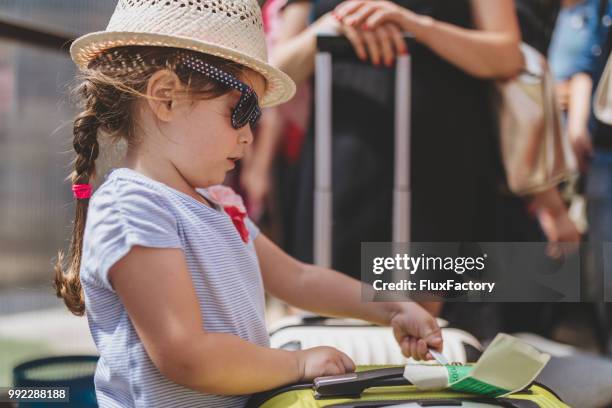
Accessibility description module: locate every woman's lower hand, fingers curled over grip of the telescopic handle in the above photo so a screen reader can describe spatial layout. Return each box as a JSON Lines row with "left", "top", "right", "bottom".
{"left": 315, "top": 12, "right": 407, "bottom": 67}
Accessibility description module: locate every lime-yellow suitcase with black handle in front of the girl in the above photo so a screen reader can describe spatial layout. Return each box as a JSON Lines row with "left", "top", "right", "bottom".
{"left": 247, "top": 367, "right": 569, "bottom": 408}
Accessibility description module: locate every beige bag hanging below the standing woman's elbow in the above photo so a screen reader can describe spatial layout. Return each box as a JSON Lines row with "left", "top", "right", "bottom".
{"left": 496, "top": 44, "right": 576, "bottom": 195}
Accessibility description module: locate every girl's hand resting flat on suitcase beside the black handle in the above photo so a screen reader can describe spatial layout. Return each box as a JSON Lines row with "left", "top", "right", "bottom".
{"left": 296, "top": 347, "right": 355, "bottom": 381}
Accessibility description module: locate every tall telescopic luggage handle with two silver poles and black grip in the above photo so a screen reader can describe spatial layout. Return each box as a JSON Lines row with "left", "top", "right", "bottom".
{"left": 314, "top": 34, "right": 411, "bottom": 267}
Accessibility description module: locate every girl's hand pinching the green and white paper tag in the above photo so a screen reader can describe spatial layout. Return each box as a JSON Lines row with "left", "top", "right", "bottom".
{"left": 390, "top": 303, "right": 442, "bottom": 360}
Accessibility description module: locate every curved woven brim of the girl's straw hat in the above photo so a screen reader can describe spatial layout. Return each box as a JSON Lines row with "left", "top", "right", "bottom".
{"left": 70, "top": 31, "right": 295, "bottom": 107}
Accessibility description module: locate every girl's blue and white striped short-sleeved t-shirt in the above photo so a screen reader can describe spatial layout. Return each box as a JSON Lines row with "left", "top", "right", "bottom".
{"left": 81, "top": 168, "right": 269, "bottom": 408}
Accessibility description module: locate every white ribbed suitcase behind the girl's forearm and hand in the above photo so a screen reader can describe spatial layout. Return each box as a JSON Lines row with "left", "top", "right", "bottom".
{"left": 270, "top": 316, "right": 482, "bottom": 366}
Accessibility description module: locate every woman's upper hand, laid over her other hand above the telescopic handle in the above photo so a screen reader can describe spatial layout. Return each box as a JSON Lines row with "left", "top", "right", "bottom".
{"left": 334, "top": 0, "right": 416, "bottom": 30}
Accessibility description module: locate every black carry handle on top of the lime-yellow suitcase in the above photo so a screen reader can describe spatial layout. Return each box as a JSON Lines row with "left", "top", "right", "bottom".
{"left": 313, "top": 367, "right": 411, "bottom": 399}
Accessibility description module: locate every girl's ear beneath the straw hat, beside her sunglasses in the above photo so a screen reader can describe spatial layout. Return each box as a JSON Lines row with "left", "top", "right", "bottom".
{"left": 146, "top": 69, "right": 183, "bottom": 122}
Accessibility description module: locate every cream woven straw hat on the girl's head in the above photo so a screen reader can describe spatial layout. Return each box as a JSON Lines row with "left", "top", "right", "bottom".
{"left": 70, "top": 0, "right": 295, "bottom": 106}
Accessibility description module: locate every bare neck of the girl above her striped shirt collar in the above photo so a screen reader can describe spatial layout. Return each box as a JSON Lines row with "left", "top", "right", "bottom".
{"left": 125, "top": 149, "right": 212, "bottom": 207}
